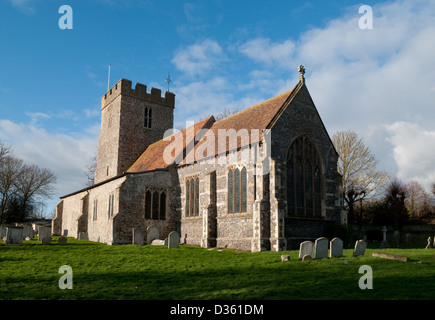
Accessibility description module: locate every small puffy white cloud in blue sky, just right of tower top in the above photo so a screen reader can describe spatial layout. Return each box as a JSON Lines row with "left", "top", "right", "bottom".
{"left": 172, "top": 39, "right": 224, "bottom": 76}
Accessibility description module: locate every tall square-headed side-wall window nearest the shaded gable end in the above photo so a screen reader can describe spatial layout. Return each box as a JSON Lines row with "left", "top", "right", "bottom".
{"left": 228, "top": 168, "right": 246, "bottom": 213}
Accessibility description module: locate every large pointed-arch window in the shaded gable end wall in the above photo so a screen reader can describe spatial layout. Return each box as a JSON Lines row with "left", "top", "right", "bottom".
{"left": 287, "top": 137, "right": 322, "bottom": 217}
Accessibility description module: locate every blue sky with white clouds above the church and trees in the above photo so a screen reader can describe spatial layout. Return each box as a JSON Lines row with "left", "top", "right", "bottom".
{"left": 0, "top": 0, "right": 435, "bottom": 215}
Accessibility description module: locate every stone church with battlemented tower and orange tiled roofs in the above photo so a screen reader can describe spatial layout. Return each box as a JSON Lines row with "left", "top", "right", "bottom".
{"left": 52, "top": 66, "right": 346, "bottom": 251}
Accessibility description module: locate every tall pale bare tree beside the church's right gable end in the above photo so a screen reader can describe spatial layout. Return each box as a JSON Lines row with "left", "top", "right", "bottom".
{"left": 332, "top": 130, "right": 389, "bottom": 222}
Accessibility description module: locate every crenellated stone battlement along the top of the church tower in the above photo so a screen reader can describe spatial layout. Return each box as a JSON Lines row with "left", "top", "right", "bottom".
{"left": 101, "top": 79, "right": 175, "bottom": 110}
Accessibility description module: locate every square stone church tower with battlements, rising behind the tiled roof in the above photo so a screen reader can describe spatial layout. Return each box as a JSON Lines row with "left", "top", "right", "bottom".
{"left": 94, "top": 79, "right": 175, "bottom": 184}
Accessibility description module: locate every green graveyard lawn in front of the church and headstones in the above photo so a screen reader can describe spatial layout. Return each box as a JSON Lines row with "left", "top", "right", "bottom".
{"left": 0, "top": 237, "right": 435, "bottom": 300}
